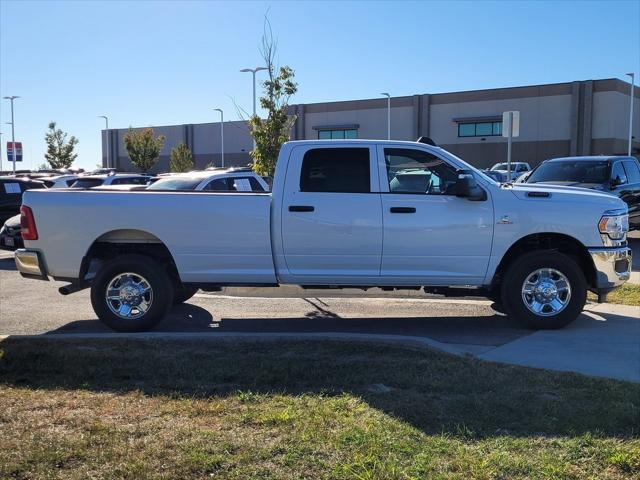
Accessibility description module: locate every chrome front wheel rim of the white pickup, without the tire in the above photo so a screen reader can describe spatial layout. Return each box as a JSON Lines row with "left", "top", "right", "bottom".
{"left": 522, "top": 268, "right": 571, "bottom": 317}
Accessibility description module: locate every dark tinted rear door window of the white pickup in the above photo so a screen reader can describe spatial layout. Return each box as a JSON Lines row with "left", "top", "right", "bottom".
{"left": 300, "top": 148, "right": 371, "bottom": 193}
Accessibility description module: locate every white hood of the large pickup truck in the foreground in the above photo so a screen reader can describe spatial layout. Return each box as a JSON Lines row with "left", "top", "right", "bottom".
{"left": 502, "top": 183, "right": 627, "bottom": 209}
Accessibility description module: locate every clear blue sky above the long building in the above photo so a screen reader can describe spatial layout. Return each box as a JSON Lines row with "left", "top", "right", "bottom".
{"left": 0, "top": 0, "right": 640, "bottom": 168}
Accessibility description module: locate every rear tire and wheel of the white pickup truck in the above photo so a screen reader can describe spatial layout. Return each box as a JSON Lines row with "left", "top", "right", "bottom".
{"left": 91, "top": 255, "right": 173, "bottom": 332}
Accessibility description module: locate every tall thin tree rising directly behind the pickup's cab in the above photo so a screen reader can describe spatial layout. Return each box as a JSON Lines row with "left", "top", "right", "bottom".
{"left": 249, "top": 18, "right": 298, "bottom": 176}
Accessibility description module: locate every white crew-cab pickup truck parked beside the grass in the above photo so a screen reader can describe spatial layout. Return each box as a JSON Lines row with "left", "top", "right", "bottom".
{"left": 16, "top": 140, "right": 631, "bottom": 331}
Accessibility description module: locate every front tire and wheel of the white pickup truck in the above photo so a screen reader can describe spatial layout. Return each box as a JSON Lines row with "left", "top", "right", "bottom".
{"left": 502, "top": 250, "right": 587, "bottom": 329}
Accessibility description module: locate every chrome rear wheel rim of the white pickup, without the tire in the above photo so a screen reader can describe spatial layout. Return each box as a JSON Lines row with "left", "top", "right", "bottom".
{"left": 105, "top": 272, "right": 153, "bottom": 320}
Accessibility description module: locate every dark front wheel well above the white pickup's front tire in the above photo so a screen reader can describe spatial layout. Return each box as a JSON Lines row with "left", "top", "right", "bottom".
{"left": 492, "top": 233, "right": 596, "bottom": 289}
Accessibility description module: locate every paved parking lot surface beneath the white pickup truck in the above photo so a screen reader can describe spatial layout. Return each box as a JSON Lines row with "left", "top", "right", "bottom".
{"left": 0, "top": 238, "right": 640, "bottom": 381}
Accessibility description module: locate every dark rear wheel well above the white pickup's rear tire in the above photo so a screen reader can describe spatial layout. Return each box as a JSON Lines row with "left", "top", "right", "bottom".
{"left": 80, "top": 230, "right": 180, "bottom": 283}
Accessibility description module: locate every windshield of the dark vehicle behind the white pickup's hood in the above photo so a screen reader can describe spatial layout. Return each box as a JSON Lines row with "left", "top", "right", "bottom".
{"left": 527, "top": 160, "right": 609, "bottom": 183}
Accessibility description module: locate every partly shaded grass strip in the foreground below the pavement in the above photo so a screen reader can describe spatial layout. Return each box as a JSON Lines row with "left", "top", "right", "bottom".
{"left": 0, "top": 339, "right": 640, "bottom": 480}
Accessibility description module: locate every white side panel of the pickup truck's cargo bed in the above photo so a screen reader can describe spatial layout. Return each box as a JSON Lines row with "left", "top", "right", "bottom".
{"left": 24, "top": 190, "right": 276, "bottom": 284}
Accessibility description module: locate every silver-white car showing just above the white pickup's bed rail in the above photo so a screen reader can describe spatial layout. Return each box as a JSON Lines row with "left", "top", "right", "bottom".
{"left": 147, "top": 168, "right": 269, "bottom": 192}
